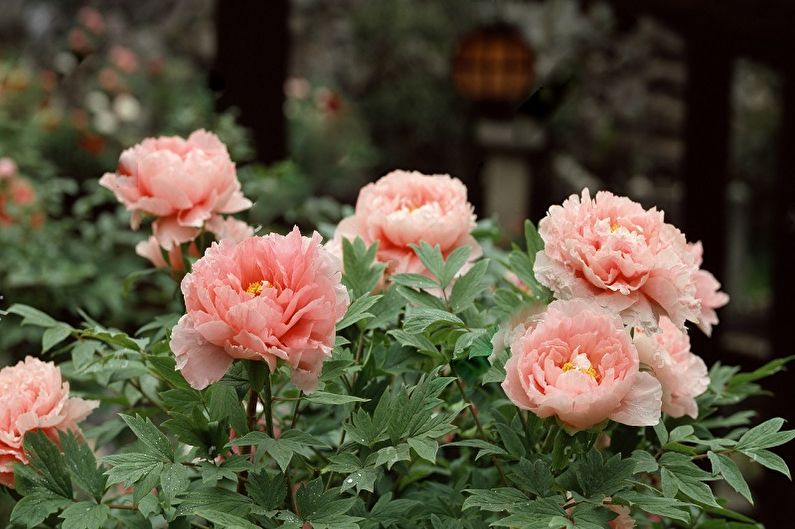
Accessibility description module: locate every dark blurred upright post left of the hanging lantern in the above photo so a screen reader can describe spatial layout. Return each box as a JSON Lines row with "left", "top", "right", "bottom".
{"left": 211, "top": 0, "right": 289, "bottom": 163}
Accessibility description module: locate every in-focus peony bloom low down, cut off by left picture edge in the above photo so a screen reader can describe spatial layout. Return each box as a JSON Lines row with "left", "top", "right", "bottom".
{"left": 0, "top": 356, "right": 99, "bottom": 487}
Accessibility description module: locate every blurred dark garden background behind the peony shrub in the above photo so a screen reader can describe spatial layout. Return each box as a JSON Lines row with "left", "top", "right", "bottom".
{"left": 0, "top": 0, "right": 795, "bottom": 528}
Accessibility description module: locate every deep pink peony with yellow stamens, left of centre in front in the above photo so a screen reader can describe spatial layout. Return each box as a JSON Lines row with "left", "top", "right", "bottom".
{"left": 171, "top": 227, "right": 349, "bottom": 391}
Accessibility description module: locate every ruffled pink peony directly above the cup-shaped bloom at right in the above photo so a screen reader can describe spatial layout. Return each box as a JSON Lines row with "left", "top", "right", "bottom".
{"left": 534, "top": 189, "right": 699, "bottom": 329}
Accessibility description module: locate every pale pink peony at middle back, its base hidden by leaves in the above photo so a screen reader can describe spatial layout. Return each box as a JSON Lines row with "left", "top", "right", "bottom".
{"left": 334, "top": 171, "right": 482, "bottom": 274}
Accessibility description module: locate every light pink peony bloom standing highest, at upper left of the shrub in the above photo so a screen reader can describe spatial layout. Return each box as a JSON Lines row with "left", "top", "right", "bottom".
{"left": 100, "top": 130, "right": 251, "bottom": 249}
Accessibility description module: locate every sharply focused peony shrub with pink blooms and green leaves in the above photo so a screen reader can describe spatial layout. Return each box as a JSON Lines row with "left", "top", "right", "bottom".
{"left": 0, "top": 133, "right": 795, "bottom": 529}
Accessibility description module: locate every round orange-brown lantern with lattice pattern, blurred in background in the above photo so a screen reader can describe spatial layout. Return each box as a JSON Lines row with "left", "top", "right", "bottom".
{"left": 453, "top": 23, "right": 535, "bottom": 106}
